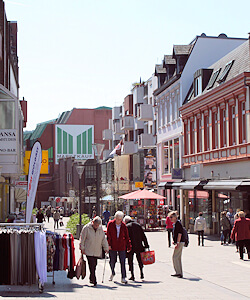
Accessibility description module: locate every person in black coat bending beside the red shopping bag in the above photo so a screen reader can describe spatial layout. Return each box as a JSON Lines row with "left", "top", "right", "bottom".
{"left": 124, "top": 216, "right": 149, "bottom": 280}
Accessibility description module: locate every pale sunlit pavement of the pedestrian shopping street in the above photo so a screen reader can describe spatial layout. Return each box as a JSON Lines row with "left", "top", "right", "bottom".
{"left": 0, "top": 218, "right": 250, "bottom": 300}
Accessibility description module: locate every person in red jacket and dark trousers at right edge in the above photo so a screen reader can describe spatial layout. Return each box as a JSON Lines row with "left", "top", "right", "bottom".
{"left": 231, "top": 211, "right": 250, "bottom": 259}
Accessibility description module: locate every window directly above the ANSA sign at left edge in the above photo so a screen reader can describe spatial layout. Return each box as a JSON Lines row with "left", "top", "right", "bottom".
{"left": 0, "top": 101, "right": 15, "bottom": 129}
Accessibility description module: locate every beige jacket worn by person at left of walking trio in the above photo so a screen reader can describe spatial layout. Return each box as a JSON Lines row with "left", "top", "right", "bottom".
{"left": 80, "top": 222, "right": 109, "bottom": 257}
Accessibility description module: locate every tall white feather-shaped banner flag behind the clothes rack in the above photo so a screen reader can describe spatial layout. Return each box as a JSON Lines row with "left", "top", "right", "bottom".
{"left": 26, "top": 142, "right": 42, "bottom": 223}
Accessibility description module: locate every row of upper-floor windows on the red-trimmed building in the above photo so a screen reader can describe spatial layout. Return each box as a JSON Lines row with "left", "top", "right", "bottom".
{"left": 184, "top": 101, "right": 246, "bottom": 155}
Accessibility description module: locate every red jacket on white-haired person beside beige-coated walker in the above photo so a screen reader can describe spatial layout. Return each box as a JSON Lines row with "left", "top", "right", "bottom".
{"left": 107, "top": 219, "right": 131, "bottom": 251}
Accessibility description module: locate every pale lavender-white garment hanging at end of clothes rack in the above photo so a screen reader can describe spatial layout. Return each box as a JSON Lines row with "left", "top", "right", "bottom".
{"left": 34, "top": 231, "right": 47, "bottom": 285}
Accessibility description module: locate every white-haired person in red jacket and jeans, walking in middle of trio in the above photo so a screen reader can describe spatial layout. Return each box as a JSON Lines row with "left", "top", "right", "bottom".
{"left": 107, "top": 211, "right": 131, "bottom": 283}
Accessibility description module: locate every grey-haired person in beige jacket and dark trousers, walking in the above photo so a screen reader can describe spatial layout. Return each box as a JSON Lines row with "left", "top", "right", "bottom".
{"left": 80, "top": 216, "right": 109, "bottom": 286}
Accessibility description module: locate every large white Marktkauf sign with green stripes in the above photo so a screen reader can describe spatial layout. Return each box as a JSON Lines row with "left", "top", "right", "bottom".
{"left": 55, "top": 125, "right": 94, "bottom": 164}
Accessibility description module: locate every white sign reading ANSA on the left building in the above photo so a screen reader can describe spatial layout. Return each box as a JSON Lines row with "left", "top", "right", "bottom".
{"left": 0, "top": 129, "right": 17, "bottom": 154}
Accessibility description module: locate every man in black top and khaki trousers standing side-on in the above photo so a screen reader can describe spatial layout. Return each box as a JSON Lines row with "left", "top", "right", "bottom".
{"left": 168, "top": 211, "right": 184, "bottom": 278}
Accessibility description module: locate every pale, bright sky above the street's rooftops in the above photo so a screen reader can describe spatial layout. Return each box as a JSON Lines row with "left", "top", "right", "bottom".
{"left": 5, "top": 0, "right": 250, "bottom": 130}
